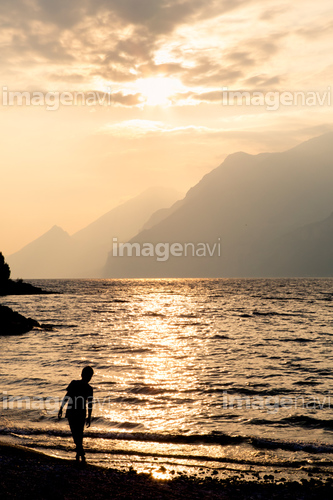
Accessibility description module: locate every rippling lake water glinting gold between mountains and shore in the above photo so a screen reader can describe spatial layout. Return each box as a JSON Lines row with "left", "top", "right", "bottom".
{"left": 0, "top": 278, "right": 333, "bottom": 478}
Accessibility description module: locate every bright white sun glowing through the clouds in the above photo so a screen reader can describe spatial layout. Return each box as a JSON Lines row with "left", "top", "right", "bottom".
{"left": 135, "top": 77, "right": 182, "bottom": 106}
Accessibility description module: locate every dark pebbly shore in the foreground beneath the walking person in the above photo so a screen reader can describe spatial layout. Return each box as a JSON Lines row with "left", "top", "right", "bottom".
{"left": 0, "top": 443, "right": 333, "bottom": 500}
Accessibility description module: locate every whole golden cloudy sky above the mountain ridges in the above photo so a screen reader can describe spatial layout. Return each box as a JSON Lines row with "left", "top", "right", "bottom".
{"left": 0, "top": 0, "right": 333, "bottom": 255}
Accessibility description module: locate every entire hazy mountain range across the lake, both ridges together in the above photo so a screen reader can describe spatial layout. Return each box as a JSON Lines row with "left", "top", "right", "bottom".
{"left": 7, "top": 132, "right": 333, "bottom": 278}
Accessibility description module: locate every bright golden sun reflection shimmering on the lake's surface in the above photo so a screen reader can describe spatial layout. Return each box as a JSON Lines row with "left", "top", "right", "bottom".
{"left": 93, "top": 285, "right": 205, "bottom": 431}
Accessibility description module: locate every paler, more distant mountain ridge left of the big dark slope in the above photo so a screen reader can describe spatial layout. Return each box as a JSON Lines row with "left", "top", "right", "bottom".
{"left": 7, "top": 188, "right": 179, "bottom": 278}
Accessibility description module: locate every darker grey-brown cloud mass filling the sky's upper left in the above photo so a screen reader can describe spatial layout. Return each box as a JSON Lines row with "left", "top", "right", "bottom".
{"left": 0, "top": 0, "right": 264, "bottom": 86}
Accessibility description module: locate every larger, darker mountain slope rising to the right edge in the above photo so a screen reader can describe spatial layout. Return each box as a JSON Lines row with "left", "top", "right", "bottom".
{"left": 104, "top": 132, "right": 333, "bottom": 278}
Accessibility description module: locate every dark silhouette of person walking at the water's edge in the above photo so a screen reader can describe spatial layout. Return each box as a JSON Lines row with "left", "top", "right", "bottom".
{"left": 58, "top": 366, "right": 94, "bottom": 462}
